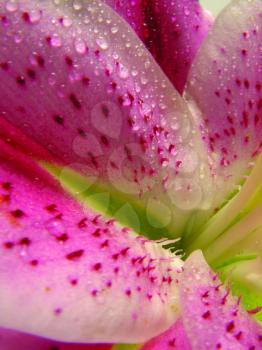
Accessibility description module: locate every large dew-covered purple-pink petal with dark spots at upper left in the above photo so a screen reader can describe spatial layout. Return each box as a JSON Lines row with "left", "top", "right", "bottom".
{"left": 0, "top": 0, "right": 212, "bottom": 236}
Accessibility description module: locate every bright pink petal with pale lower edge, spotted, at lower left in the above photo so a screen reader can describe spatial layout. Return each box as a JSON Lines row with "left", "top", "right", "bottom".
{"left": 0, "top": 142, "right": 181, "bottom": 343}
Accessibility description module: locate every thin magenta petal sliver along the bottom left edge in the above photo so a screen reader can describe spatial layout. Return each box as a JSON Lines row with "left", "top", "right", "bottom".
{"left": 0, "top": 328, "right": 112, "bottom": 350}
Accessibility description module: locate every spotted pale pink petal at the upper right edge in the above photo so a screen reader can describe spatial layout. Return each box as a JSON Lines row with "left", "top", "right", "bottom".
{"left": 187, "top": 0, "right": 262, "bottom": 197}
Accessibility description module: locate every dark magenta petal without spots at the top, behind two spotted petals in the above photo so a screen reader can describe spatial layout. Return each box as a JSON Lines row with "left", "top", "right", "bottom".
{"left": 104, "top": 0, "right": 212, "bottom": 93}
